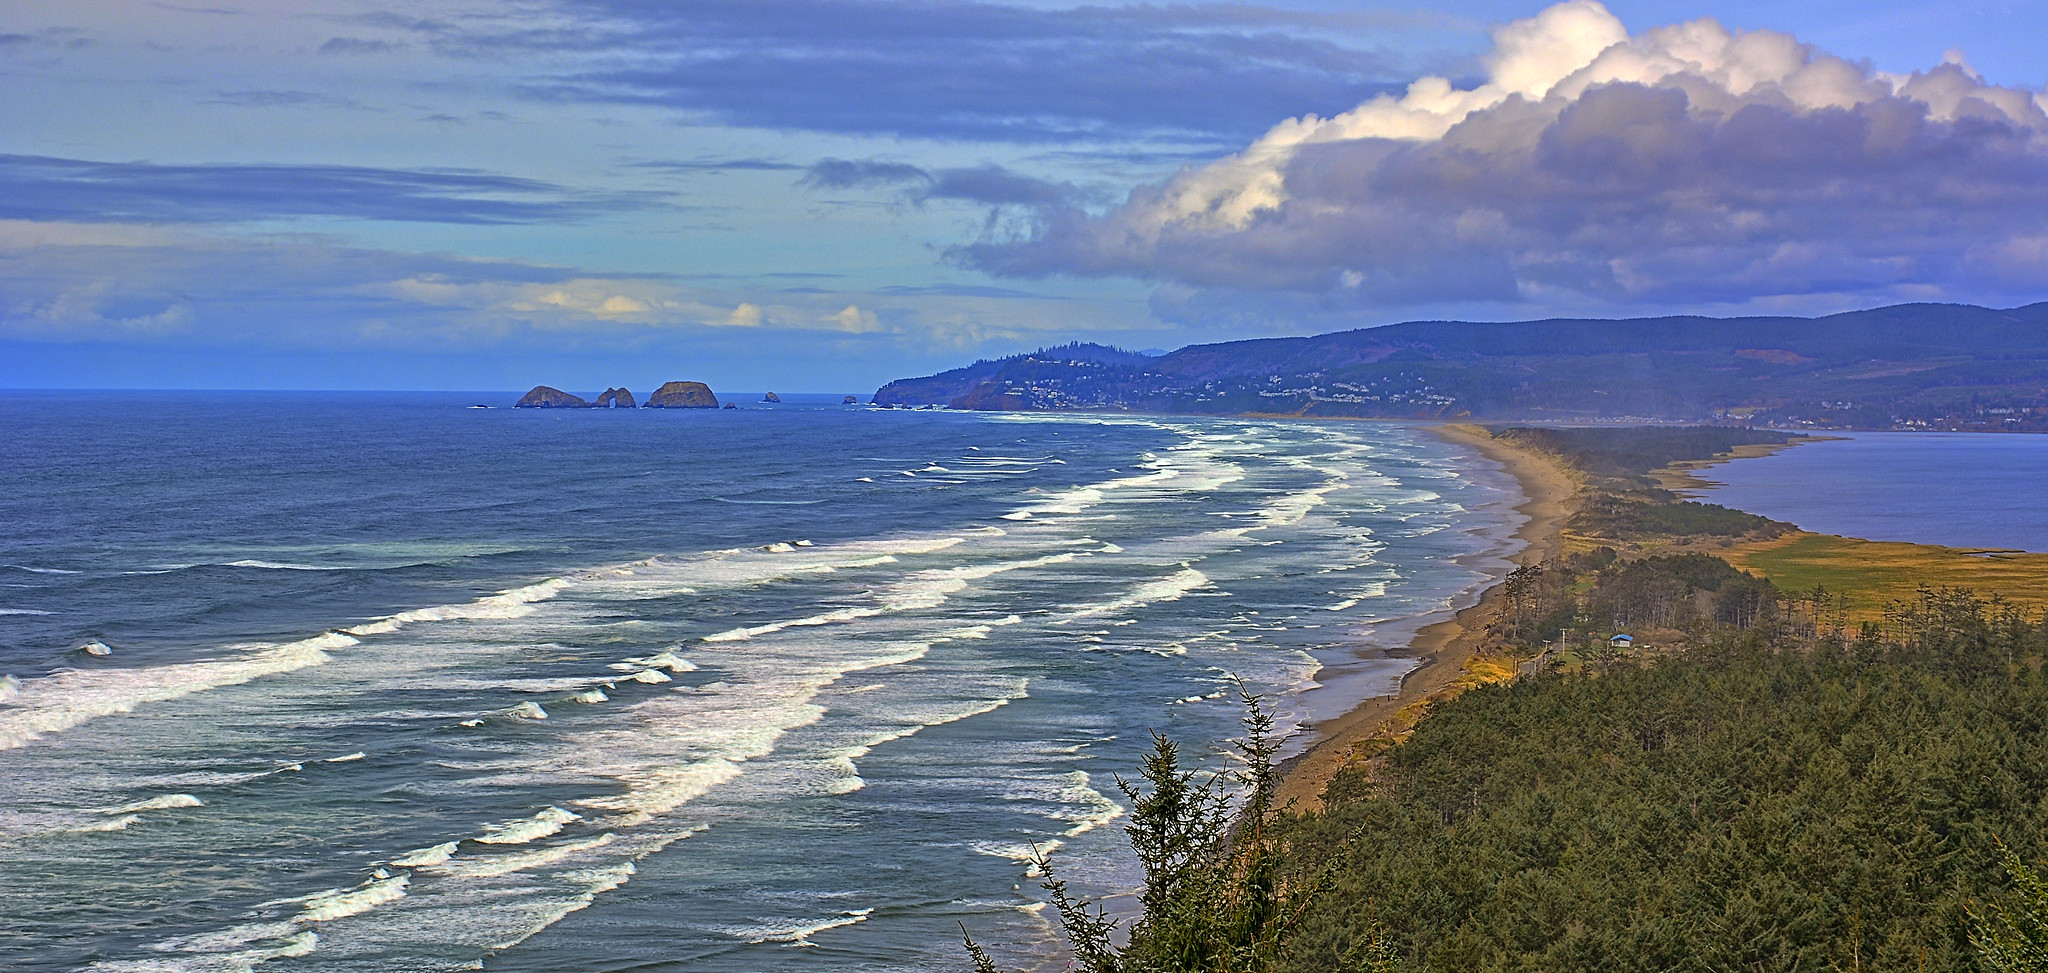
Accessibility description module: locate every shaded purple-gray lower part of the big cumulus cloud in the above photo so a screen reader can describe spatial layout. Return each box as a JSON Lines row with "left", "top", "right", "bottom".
{"left": 952, "top": 76, "right": 2048, "bottom": 318}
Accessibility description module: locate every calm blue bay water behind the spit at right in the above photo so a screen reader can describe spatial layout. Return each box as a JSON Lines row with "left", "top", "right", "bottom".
{"left": 1700, "top": 432, "right": 2048, "bottom": 551}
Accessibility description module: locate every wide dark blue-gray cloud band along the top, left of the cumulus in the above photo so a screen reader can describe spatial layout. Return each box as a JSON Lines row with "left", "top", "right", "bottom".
{"left": 391, "top": 0, "right": 1415, "bottom": 143}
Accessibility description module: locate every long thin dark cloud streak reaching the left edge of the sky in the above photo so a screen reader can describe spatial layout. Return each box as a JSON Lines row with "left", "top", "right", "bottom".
{"left": 0, "top": 156, "right": 653, "bottom": 223}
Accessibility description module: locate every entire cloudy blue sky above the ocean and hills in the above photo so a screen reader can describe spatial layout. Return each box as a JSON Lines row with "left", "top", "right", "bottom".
{"left": 0, "top": 0, "right": 2048, "bottom": 393}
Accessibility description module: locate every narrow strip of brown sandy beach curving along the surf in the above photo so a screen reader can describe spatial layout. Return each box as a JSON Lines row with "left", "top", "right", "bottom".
{"left": 1280, "top": 424, "right": 1579, "bottom": 809}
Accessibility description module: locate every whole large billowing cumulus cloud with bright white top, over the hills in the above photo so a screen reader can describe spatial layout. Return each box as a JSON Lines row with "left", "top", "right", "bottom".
{"left": 954, "top": 0, "right": 2048, "bottom": 307}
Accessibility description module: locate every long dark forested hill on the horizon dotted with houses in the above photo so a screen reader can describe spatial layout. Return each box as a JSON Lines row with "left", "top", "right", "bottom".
{"left": 874, "top": 303, "right": 2048, "bottom": 430}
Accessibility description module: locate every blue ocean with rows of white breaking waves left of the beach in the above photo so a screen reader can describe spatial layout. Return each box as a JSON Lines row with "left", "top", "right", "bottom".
{"left": 0, "top": 391, "right": 1520, "bottom": 971}
